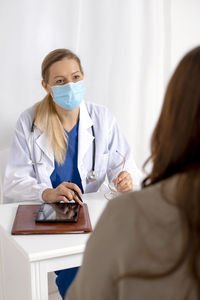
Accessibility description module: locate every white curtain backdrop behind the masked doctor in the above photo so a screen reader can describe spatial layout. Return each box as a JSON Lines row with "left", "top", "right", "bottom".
{"left": 0, "top": 0, "right": 170, "bottom": 171}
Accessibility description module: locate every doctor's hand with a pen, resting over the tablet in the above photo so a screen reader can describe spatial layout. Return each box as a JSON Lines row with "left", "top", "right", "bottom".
{"left": 42, "top": 181, "right": 83, "bottom": 205}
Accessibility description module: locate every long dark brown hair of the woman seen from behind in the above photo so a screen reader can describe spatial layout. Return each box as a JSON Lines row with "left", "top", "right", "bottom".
{"left": 117, "top": 47, "right": 200, "bottom": 290}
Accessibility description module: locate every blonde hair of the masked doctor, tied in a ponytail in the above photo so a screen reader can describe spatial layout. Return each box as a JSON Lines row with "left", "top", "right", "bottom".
{"left": 34, "top": 49, "right": 83, "bottom": 164}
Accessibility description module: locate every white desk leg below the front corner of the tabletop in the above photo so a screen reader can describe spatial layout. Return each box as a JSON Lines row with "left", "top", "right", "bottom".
{"left": 31, "top": 261, "right": 48, "bottom": 300}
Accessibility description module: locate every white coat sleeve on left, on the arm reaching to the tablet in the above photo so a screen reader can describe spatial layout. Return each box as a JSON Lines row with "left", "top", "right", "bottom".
{"left": 3, "top": 115, "right": 47, "bottom": 202}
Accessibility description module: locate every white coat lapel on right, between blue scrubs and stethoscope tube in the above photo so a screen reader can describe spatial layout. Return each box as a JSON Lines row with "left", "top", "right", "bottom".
{"left": 78, "top": 101, "right": 94, "bottom": 166}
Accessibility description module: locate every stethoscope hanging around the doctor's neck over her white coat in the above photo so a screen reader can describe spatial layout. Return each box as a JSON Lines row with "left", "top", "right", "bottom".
{"left": 30, "top": 120, "right": 97, "bottom": 182}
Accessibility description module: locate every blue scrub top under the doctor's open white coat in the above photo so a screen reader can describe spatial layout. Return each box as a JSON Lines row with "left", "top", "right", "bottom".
{"left": 50, "top": 121, "right": 84, "bottom": 193}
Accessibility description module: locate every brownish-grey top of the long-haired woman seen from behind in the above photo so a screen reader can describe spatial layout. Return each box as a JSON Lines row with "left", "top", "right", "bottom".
{"left": 65, "top": 178, "right": 197, "bottom": 300}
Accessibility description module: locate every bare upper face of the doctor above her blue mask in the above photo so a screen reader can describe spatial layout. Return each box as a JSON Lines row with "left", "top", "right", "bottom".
{"left": 49, "top": 58, "right": 80, "bottom": 79}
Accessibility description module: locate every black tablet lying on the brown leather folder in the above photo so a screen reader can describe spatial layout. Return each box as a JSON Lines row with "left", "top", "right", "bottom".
{"left": 35, "top": 202, "right": 80, "bottom": 223}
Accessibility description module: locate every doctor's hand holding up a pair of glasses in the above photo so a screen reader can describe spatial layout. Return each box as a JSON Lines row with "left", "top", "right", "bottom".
{"left": 113, "top": 171, "right": 133, "bottom": 193}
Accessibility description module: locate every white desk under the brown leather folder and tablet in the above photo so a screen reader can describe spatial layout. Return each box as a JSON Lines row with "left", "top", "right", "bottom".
{"left": 0, "top": 193, "right": 108, "bottom": 300}
